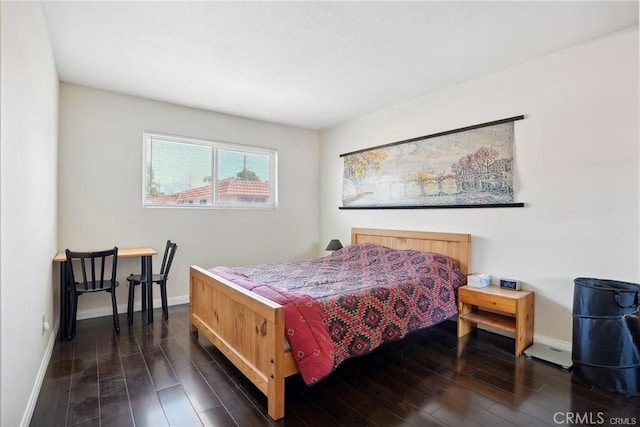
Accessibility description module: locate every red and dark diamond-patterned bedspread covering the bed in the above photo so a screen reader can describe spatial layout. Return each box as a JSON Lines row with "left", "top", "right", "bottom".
{"left": 211, "top": 243, "right": 463, "bottom": 384}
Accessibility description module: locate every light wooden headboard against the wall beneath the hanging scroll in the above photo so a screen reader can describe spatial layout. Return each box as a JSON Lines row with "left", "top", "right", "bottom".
{"left": 351, "top": 228, "right": 471, "bottom": 279}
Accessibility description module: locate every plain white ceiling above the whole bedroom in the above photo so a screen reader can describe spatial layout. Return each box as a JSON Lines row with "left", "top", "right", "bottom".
{"left": 41, "top": 1, "right": 638, "bottom": 130}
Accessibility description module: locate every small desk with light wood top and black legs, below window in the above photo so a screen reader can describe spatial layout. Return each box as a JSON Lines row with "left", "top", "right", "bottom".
{"left": 53, "top": 247, "right": 158, "bottom": 341}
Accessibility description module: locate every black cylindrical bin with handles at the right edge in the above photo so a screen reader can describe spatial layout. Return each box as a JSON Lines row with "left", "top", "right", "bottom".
{"left": 571, "top": 277, "right": 640, "bottom": 396}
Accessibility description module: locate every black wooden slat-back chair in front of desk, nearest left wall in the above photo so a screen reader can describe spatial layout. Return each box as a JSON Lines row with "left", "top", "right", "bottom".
{"left": 65, "top": 247, "right": 120, "bottom": 338}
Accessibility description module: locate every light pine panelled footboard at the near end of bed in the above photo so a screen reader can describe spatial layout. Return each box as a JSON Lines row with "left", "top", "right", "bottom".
{"left": 190, "top": 266, "right": 298, "bottom": 420}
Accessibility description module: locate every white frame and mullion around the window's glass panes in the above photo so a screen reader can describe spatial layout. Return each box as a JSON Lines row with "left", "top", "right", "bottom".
{"left": 141, "top": 131, "right": 278, "bottom": 210}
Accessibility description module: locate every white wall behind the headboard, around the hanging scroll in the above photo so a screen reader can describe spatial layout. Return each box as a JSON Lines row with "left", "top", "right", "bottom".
{"left": 320, "top": 27, "right": 640, "bottom": 347}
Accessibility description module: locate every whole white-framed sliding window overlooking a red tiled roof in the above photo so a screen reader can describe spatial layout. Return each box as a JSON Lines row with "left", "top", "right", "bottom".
{"left": 142, "top": 132, "right": 278, "bottom": 208}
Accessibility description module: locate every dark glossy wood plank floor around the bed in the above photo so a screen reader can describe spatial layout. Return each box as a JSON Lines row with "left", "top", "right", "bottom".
{"left": 31, "top": 306, "right": 640, "bottom": 427}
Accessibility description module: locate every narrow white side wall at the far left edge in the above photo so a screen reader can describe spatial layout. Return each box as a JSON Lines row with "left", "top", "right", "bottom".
{"left": 0, "top": 2, "right": 58, "bottom": 426}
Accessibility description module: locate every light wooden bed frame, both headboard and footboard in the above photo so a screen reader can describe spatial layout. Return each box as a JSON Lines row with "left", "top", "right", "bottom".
{"left": 190, "top": 228, "right": 471, "bottom": 420}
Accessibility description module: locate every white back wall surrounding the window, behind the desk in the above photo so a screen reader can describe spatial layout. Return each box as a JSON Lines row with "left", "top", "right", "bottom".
{"left": 58, "top": 83, "right": 320, "bottom": 318}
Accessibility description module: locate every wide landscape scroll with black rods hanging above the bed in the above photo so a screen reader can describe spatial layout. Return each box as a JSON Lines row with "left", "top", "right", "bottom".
{"left": 340, "top": 116, "right": 524, "bottom": 209}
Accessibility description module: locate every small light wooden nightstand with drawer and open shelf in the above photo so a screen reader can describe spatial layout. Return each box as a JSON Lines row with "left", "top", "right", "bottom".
{"left": 458, "top": 286, "right": 534, "bottom": 356}
